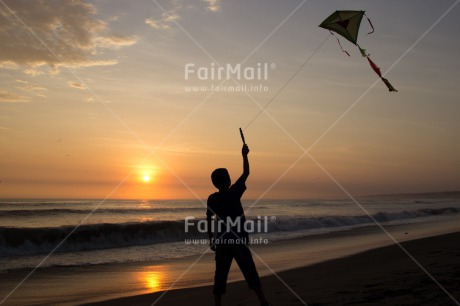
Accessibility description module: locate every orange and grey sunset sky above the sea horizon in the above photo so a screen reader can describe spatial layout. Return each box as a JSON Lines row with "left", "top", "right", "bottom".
{"left": 0, "top": 0, "right": 460, "bottom": 199}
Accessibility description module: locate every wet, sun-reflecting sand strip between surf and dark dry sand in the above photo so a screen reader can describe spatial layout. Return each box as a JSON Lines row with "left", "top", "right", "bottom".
{"left": 0, "top": 216, "right": 460, "bottom": 306}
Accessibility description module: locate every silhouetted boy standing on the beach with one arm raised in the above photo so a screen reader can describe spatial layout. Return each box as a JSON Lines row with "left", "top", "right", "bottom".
{"left": 206, "top": 144, "right": 270, "bottom": 306}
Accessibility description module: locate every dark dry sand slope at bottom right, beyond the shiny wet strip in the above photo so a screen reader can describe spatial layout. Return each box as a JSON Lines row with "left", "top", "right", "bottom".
{"left": 85, "top": 232, "right": 460, "bottom": 306}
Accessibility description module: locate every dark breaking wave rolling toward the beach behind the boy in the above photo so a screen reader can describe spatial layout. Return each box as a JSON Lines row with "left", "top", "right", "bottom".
{"left": 0, "top": 207, "right": 460, "bottom": 257}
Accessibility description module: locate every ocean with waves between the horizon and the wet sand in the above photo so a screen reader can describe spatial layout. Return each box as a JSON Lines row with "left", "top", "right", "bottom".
{"left": 0, "top": 193, "right": 460, "bottom": 272}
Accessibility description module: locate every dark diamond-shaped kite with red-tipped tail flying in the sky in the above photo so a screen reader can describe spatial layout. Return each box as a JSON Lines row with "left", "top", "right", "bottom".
{"left": 319, "top": 11, "right": 397, "bottom": 91}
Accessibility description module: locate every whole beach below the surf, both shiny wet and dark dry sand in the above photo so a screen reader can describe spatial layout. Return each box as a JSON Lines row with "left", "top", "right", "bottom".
{"left": 0, "top": 215, "right": 460, "bottom": 306}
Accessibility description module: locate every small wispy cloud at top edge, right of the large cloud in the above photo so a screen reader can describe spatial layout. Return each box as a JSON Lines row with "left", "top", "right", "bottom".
{"left": 145, "top": 0, "right": 222, "bottom": 30}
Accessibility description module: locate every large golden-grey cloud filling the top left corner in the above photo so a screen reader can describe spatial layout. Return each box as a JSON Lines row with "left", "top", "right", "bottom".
{"left": 0, "top": 0, "right": 136, "bottom": 75}
